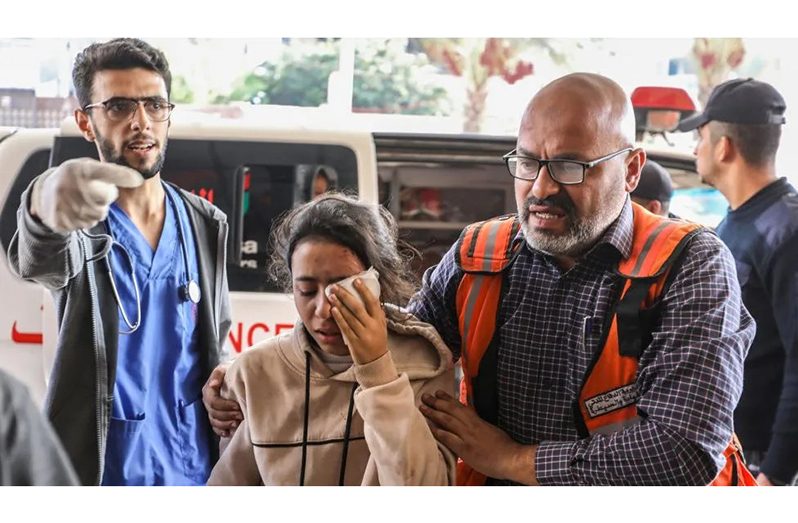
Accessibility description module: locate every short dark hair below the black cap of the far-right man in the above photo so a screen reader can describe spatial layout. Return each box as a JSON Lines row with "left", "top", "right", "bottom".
{"left": 709, "top": 120, "right": 781, "bottom": 167}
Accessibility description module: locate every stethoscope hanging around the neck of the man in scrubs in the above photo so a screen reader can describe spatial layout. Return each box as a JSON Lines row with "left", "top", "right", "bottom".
{"left": 80, "top": 182, "right": 202, "bottom": 334}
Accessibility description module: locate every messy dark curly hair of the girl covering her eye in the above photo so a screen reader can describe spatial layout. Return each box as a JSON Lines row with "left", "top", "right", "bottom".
{"left": 269, "top": 192, "right": 418, "bottom": 306}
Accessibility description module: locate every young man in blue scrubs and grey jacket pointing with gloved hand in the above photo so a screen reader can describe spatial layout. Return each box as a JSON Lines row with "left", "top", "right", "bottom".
{"left": 10, "top": 39, "right": 230, "bottom": 485}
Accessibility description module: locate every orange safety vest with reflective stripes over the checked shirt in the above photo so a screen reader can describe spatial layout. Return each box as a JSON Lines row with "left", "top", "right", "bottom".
{"left": 456, "top": 203, "right": 756, "bottom": 486}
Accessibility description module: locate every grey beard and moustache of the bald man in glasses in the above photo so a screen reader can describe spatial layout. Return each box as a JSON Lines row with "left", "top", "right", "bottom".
{"left": 518, "top": 180, "right": 626, "bottom": 258}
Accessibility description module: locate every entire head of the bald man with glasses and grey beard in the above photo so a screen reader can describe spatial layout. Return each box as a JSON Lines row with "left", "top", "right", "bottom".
{"left": 514, "top": 73, "right": 646, "bottom": 263}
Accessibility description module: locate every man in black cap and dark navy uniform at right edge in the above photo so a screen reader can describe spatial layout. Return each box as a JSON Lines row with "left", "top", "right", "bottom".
{"left": 678, "top": 79, "right": 798, "bottom": 485}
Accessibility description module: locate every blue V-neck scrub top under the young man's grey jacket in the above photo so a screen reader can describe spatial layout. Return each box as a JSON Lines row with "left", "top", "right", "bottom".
{"left": 102, "top": 184, "right": 216, "bottom": 485}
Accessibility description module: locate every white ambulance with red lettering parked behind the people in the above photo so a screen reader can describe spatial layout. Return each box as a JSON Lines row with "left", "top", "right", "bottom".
{"left": 0, "top": 92, "right": 712, "bottom": 401}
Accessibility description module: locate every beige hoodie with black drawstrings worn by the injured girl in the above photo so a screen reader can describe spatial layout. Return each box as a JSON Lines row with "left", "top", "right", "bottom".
{"left": 208, "top": 305, "right": 455, "bottom": 485}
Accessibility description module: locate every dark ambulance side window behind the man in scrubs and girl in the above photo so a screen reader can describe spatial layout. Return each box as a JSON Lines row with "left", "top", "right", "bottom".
{"left": 53, "top": 137, "right": 358, "bottom": 292}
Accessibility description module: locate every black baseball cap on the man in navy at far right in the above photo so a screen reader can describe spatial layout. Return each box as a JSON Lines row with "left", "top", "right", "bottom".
{"left": 676, "top": 78, "right": 787, "bottom": 131}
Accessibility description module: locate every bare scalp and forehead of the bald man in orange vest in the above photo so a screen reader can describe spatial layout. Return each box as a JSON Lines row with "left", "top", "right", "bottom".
{"left": 521, "top": 73, "right": 635, "bottom": 147}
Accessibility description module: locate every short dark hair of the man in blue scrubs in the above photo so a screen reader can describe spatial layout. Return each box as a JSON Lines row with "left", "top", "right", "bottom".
{"left": 72, "top": 38, "right": 172, "bottom": 107}
